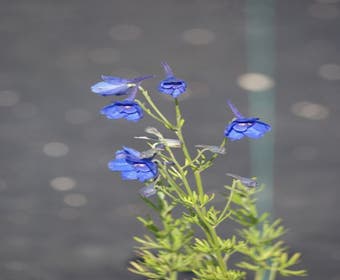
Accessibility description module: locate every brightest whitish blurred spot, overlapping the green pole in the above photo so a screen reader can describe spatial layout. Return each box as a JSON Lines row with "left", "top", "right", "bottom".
{"left": 237, "top": 73, "right": 275, "bottom": 92}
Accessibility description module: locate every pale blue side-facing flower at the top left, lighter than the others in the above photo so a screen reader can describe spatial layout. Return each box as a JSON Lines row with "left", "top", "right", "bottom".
{"left": 91, "top": 76, "right": 153, "bottom": 96}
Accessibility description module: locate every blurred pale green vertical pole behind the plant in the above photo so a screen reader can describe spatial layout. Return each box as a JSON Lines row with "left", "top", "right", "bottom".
{"left": 245, "top": 0, "right": 275, "bottom": 280}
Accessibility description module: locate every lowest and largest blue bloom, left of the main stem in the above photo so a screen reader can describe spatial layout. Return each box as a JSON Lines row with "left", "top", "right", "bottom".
{"left": 108, "top": 147, "right": 158, "bottom": 182}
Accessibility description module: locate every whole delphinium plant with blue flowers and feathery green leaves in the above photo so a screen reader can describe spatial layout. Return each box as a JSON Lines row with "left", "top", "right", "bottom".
{"left": 91, "top": 63, "right": 306, "bottom": 280}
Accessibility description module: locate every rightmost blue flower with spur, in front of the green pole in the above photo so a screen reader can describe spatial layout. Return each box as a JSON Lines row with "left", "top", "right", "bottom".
{"left": 224, "top": 101, "right": 271, "bottom": 141}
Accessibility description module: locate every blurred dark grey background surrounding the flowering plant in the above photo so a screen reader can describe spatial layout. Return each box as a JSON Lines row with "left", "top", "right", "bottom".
{"left": 0, "top": 0, "right": 340, "bottom": 280}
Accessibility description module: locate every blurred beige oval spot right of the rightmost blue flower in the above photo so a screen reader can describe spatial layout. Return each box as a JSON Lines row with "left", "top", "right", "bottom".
{"left": 291, "top": 101, "right": 329, "bottom": 120}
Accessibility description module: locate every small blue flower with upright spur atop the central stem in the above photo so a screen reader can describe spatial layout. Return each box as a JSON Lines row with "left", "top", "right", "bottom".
{"left": 158, "top": 62, "right": 187, "bottom": 98}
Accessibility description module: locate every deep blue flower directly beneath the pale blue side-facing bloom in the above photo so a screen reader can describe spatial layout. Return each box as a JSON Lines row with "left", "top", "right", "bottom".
{"left": 100, "top": 86, "right": 143, "bottom": 122}
